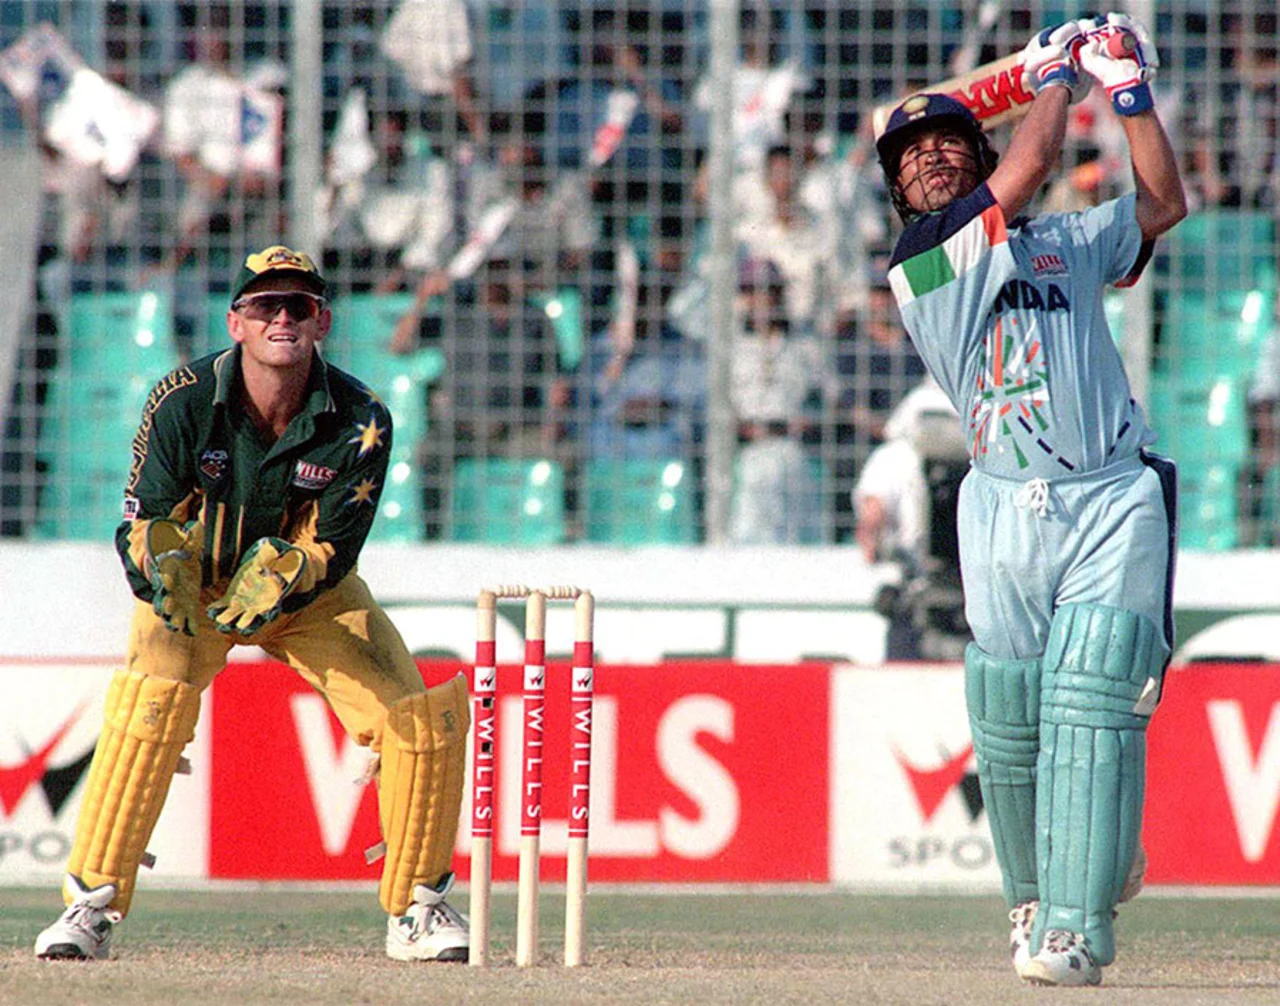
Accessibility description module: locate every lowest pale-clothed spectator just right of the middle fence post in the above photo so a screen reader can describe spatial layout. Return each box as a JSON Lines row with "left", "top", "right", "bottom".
{"left": 730, "top": 259, "right": 823, "bottom": 545}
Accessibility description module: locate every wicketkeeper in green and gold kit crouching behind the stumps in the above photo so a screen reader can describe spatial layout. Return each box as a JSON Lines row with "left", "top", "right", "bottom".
{"left": 36, "top": 246, "right": 470, "bottom": 961}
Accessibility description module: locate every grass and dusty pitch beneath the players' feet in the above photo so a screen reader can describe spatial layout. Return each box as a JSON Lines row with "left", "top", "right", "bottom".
{"left": 0, "top": 890, "right": 1280, "bottom": 1006}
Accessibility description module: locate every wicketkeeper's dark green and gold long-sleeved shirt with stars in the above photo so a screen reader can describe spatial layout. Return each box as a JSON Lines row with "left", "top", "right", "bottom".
{"left": 115, "top": 346, "right": 392, "bottom": 612}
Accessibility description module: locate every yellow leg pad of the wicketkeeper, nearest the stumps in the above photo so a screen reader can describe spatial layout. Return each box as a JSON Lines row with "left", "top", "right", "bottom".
{"left": 378, "top": 675, "right": 471, "bottom": 915}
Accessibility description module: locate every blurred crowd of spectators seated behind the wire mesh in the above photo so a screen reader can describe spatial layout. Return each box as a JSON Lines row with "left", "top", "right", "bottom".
{"left": 0, "top": 0, "right": 1280, "bottom": 547}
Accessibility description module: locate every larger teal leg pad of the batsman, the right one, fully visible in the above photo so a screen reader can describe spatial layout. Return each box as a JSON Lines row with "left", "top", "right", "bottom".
{"left": 1032, "top": 604, "right": 1167, "bottom": 965}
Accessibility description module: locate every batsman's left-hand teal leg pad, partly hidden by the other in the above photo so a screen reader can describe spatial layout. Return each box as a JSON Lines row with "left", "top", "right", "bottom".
{"left": 964, "top": 643, "right": 1042, "bottom": 907}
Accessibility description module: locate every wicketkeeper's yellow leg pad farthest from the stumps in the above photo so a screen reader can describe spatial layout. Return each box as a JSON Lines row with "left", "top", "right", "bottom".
{"left": 64, "top": 671, "right": 200, "bottom": 915}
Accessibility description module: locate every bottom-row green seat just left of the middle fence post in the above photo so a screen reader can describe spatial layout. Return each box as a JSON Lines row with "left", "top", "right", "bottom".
{"left": 585, "top": 459, "right": 698, "bottom": 545}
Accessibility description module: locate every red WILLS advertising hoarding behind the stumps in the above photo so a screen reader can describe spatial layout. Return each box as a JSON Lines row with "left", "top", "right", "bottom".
{"left": 207, "top": 660, "right": 831, "bottom": 883}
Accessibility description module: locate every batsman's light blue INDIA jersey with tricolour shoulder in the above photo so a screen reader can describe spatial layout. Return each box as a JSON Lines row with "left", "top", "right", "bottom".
{"left": 888, "top": 183, "right": 1156, "bottom": 480}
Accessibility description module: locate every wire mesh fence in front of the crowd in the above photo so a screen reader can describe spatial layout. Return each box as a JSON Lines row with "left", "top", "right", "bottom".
{"left": 0, "top": 0, "right": 1280, "bottom": 549}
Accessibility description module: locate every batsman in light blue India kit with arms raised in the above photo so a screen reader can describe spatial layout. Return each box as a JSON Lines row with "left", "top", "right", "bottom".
{"left": 877, "top": 14, "right": 1187, "bottom": 986}
